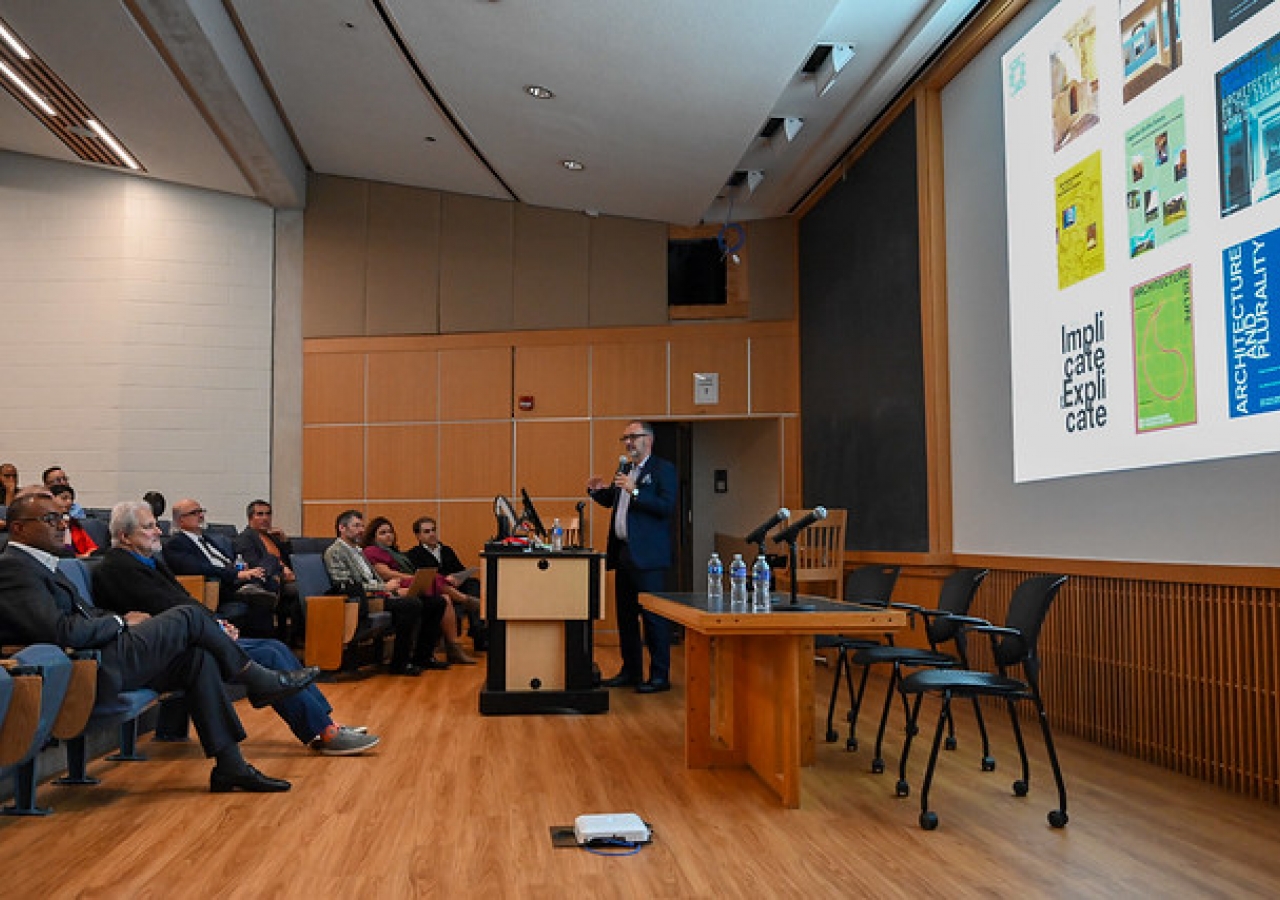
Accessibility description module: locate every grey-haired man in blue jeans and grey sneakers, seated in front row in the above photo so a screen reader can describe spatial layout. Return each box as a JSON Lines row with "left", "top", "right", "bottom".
{"left": 92, "top": 501, "right": 379, "bottom": 757}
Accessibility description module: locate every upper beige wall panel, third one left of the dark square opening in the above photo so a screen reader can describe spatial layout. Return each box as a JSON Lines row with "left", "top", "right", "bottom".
{"left": 440, "top": 193, "right": 516, "bottom": 333}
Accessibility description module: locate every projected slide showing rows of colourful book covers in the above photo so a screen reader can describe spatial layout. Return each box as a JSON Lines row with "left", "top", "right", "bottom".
{"left": 1002, "top": 0, "right": 1280, "bottom": 481}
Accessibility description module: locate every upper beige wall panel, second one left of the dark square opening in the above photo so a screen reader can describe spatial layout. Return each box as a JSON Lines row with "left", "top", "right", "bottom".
{"left": 512, "top": 204, "right": 590, "bottom": 329}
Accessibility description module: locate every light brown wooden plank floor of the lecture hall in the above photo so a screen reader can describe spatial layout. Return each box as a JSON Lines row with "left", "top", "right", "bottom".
{"left": 0, "top": 648, "right": 1280, "bottom": 899}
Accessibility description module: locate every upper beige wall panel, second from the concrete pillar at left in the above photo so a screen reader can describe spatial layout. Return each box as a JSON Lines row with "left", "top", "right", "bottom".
{"left": 365, "top": 182, "right": 440, "bottom": 334}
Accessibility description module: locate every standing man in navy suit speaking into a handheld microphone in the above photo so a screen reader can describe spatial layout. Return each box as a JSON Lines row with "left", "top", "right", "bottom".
{"left": 586, "top": 421, "right": 678, "bottom": 694}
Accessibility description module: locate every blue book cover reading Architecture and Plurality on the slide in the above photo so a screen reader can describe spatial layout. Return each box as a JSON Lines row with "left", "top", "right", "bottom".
{"left": 1222, "top": 229, "right": 1280, "bottom": 419}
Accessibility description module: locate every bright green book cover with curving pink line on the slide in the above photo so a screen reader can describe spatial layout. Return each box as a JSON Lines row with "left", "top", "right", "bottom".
{"left": 1130, "top": 266, "right": 1196, "bottom": 434}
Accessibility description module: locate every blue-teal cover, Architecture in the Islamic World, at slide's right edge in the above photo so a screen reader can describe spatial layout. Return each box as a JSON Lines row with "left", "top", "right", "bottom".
{"left": 1216, "top": 35, "right": 1280, "bottom": 216}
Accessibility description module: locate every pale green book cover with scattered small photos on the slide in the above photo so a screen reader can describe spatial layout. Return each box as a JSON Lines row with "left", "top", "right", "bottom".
{"left": 1124, "top": 97, "right": 1189, "bottom": 257}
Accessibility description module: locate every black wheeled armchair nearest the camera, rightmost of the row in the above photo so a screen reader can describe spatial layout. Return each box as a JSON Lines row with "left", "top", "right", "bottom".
{"left": 896, "top": 575, "right": 1066, "bottom": 831}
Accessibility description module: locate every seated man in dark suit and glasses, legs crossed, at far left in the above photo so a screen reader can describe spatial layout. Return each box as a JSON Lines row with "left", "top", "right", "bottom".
{"left": 0, "top": 492, "right": 319, "bottom": 792}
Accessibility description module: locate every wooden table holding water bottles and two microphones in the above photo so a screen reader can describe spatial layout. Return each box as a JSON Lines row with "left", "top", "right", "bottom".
{"left": 640, "top": 593, "right": 906, "bottom": 808}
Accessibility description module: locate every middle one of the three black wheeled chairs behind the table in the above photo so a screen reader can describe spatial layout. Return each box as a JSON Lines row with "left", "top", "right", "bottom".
{"left": 846, "top": 568, "right": 995, "bottom": 775}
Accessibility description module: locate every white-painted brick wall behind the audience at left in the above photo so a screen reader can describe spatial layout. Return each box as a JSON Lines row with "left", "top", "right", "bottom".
{"left": 0, "top": 152, "right": 274, "bottom": 526}
